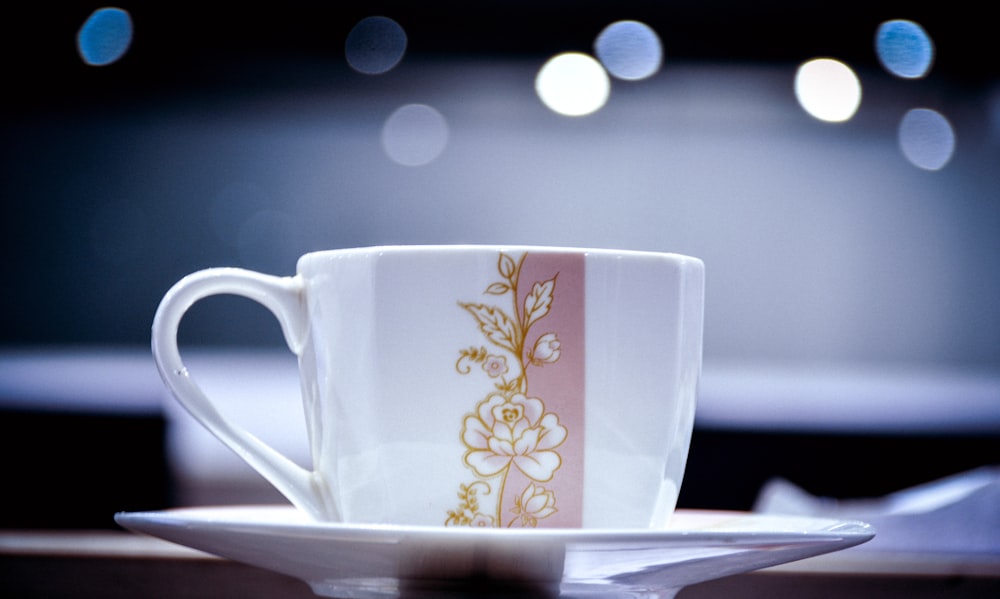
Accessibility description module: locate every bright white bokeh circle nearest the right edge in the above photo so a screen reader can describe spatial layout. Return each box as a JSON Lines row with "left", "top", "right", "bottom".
{"left": 795, "top": 58, "right": 861, "bottom": 123}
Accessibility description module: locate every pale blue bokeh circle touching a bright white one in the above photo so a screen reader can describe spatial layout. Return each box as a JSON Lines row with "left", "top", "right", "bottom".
{"left": 594, "top": 21, "right": 663, "bottom": 81}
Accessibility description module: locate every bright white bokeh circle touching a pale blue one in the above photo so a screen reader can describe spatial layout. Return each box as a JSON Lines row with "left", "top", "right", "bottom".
{"left": 535, "top": 52, "right": 611, "bottom": 116}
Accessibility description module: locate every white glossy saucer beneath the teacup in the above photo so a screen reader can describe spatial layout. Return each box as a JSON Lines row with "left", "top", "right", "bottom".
{"left": 115, "top": 506, "right": 875, "bottom": 599}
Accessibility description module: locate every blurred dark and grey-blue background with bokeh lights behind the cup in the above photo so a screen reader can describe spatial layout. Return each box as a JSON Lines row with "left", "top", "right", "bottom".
{"left": 0, "top": 0, "right": 1000, "bottom": 526}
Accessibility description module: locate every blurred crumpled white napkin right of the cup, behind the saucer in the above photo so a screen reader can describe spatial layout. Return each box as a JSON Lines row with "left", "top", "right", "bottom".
{"left": 754, "top": 466, "right": 1000, "bottom": 557}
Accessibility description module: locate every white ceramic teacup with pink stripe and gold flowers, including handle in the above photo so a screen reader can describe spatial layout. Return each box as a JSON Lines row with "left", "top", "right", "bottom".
{"left": 153, "top": 246, "right": 704, "bottom": 528}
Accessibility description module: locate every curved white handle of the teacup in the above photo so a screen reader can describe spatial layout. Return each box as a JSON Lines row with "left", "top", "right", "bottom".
{"left": 152, "top": 268, "right": 339, "bottom": 520}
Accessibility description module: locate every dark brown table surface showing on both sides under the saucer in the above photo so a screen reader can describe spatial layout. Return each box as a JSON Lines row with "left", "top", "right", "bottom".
{"left": 0, "top": 530, "right": 1000, "bottom": 599}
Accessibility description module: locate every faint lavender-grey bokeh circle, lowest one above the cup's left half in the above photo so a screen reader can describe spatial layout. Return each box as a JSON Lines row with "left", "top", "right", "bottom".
{"left": 382, "top": 104, "right": 448, "bottom": 166}
